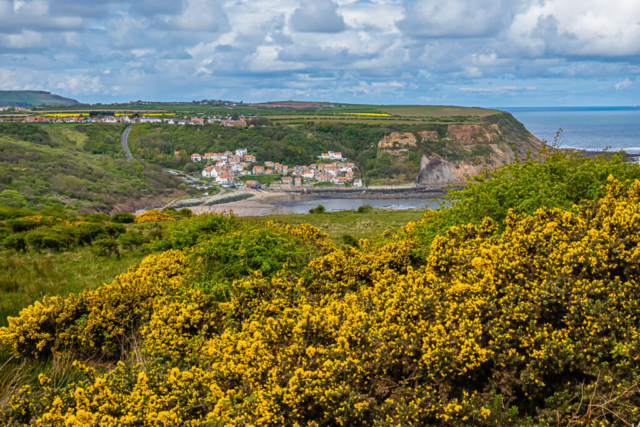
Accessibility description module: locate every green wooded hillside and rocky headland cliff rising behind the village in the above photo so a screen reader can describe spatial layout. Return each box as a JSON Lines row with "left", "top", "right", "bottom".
{"left": 129, "top": 111, "right": 540, "bottom": 185}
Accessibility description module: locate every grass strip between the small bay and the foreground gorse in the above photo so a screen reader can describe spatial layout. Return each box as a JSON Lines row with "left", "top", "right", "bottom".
{"left": 242, "top": 209, "right": 425, "bottom": 243}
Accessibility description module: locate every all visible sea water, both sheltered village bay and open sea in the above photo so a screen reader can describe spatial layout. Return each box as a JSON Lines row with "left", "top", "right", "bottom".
{"left": 271, "top": 107, "right": 640, "bottom": 213}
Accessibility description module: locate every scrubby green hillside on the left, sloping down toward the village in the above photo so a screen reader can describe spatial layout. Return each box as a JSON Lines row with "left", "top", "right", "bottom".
{"left": 0, "top": 124, "right": 180, "bottom": 212}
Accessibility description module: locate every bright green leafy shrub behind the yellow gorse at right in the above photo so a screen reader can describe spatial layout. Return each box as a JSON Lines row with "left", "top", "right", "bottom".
{"left": 402, "top": 148, "right": 640, "bottom": 254}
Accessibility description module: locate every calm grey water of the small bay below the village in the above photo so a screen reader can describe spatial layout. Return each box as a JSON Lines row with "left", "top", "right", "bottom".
{"left": 269, "top": 196, "right": 438, "bottom": 213}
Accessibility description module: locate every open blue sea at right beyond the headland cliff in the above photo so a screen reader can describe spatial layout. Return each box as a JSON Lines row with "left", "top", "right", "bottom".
{"left": 504, "top": 107, "right": 640, "bottom": 153}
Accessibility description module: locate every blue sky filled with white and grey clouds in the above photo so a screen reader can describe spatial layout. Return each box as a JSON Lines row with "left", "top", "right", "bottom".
{"left": 0, "top": 0, "right": 640, "bottom": 107}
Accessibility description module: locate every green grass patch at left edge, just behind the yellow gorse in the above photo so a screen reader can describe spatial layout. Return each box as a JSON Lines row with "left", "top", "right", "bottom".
{"left": 0, "top": 247, "right": 144, "bottom": 326}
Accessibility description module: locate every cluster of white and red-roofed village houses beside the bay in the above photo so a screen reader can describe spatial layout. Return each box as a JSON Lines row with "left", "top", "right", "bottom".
{"left": 189, "top": 148, "right": 362, "bottom": 189}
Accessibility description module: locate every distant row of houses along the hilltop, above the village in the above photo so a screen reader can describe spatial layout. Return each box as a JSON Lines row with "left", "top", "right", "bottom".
{"left": 17, "top": 114, "right": 247, "bottom": 127}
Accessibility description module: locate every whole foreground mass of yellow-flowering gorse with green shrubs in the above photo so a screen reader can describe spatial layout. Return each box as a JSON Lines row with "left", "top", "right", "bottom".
{"left": 0, "top": 151, "right": 640, "bottom": 426}
